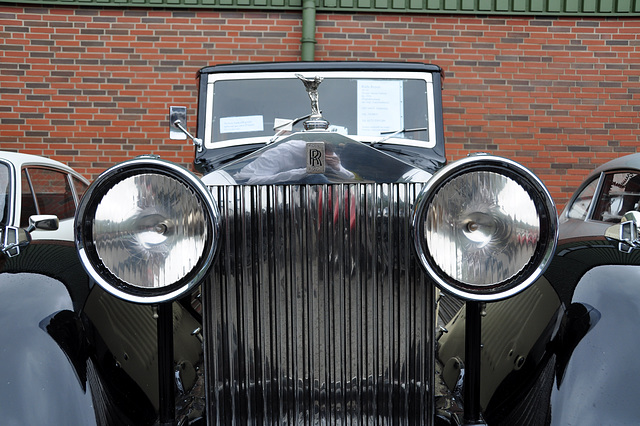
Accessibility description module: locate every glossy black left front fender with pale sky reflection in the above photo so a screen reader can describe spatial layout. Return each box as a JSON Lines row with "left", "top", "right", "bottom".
{"left": 0, "top": 241, "right": 157, "bottom": 426}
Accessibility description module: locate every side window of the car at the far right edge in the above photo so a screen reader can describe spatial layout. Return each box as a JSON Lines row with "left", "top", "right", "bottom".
{"left": 593, "top": 172, "right": 640, "bottom": 223}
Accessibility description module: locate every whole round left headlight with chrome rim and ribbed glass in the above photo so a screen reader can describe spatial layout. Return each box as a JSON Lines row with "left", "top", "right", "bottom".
{"left": 75, "top": 156, "right": 219, "bottom": 303}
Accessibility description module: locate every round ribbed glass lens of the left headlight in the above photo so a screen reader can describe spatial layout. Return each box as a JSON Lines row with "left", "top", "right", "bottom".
{"left": 93, "top": 173, "right": 208, "bottom": 288}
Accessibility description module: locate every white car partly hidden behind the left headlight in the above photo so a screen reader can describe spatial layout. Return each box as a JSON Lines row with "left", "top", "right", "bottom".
{"left": 0, "top": 151, "right": 89, "bottom": 241}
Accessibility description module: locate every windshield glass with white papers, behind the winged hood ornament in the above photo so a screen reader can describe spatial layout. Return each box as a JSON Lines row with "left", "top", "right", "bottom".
{"left": 205, "top": 76, "right": 435, "bottom": 148}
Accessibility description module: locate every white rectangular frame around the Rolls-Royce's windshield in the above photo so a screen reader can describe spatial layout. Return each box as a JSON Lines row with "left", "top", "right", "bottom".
{"left": 203, "top": 70, "right": 437, "bottom": 150}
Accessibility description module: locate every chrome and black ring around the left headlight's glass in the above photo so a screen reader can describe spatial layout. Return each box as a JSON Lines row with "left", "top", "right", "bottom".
{"left": 74, "top": 156, "right": 220, "bottom": 304}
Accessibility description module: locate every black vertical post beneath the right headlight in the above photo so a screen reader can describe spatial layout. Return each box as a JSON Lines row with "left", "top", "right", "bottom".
{"left": 464, "top": 300, "right": 486, "bottom": 426}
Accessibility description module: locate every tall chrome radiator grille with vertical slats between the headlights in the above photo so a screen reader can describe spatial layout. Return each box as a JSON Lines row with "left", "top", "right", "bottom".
{"left": 203, "top": 184, "right": 434, "bottom": 424}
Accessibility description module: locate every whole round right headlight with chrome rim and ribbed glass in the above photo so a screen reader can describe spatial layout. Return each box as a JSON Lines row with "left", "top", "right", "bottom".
{"left": 413, "top": 155, "right": 558, "bottom": 301}
